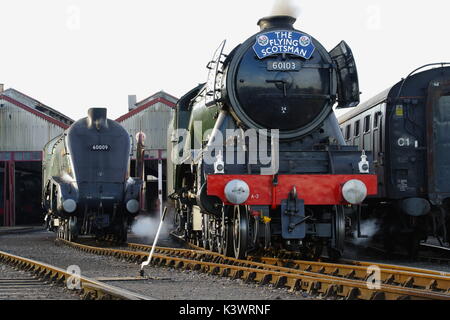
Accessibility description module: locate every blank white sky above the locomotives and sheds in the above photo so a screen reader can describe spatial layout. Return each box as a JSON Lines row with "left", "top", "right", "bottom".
{"left": 0, "top": 0, "right": 450, "bottom": 119}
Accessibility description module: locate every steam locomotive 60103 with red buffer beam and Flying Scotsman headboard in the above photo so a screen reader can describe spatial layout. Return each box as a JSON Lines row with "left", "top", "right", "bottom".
{"left": 168, "top": 16, "right": 377, "bottom": 258}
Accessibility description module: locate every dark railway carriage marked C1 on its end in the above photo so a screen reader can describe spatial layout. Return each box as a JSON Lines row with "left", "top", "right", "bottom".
{"left": 339, "top": 63, "right": 450, "bottom": 255}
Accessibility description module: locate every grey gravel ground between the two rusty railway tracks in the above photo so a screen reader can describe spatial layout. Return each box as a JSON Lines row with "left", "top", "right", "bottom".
{"left": 0, "top": 231, "right": 312, "bottom": 300}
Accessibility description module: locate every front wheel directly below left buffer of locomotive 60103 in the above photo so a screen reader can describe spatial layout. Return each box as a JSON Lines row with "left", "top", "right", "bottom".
{"left": 232, "top": 206, "right": 248, "bottom": 259}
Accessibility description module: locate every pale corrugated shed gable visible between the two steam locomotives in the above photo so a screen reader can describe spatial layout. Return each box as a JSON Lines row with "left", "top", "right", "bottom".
{"left": 116, "top": 91, "right": 178, "bottom": 212}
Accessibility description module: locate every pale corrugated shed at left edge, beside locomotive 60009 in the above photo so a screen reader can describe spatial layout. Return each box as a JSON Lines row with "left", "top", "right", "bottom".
{"left": 0, "top": 84, "right": 73, "bottom": 226}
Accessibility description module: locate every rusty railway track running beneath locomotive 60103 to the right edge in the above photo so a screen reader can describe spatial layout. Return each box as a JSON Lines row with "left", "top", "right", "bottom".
{"left": 58, "top": 240, "right": 450, "bottom": 300}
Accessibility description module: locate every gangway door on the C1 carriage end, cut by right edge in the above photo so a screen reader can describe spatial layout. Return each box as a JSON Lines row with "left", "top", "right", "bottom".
{"left": 427, "top": 80, "right": 450, "bottom": 204}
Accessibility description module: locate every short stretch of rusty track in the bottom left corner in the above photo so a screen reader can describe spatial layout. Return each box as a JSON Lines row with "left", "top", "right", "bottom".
{"left": 0, "top": 251, "right": 151, "bottom": 300}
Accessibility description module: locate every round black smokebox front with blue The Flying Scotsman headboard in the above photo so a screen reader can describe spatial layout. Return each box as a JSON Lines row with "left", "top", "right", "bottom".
{"left": 225, "top": 16, "right": 340, "bottom": 139}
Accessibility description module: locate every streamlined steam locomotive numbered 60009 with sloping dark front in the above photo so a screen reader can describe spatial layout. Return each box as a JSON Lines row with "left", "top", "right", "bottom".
{"left": 42, "top": 108, "right": 142, "bottom": 242}
